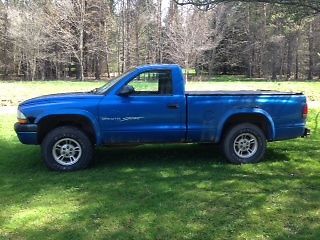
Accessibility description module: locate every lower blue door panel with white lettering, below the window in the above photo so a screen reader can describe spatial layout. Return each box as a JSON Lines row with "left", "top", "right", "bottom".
{"left": 99, "top": 96, "right": 186, "bottom": 144}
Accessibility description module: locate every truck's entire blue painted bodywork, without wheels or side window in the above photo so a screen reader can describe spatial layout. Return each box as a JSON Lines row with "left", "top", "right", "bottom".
{"left": 17, "top": 64, "right": 306, "bottom": 145}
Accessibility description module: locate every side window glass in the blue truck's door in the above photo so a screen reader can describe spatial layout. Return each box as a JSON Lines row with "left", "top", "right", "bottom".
{"left": 128, "top": 70, "right": 172, "bottom": 95}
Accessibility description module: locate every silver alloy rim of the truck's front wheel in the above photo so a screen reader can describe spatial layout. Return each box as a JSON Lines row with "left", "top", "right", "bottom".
{"left": 52, "top": 138, "right": 82, "bottom": 166}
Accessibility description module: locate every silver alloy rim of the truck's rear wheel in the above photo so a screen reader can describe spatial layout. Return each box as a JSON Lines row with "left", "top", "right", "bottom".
{"left": 233, "top": 133, "right": 258, "bottom": 158}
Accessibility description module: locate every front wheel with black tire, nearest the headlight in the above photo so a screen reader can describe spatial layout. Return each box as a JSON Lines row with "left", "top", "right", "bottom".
{"left": 41, "top": 126, "right": 93, "bottom": 172}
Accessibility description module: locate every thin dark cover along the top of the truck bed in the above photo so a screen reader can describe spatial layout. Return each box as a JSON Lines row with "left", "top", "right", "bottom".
{"left": 185, "top": 90, "right": 303, "bottom": 96}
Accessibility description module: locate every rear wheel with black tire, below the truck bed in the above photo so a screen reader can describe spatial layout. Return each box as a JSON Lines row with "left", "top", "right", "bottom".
{"left": 222, "top": 123, "right": 267, "bottom": 164}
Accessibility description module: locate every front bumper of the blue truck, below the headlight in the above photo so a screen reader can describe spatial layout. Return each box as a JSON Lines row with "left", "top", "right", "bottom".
{"left": 14, "top": 123, "right": 38, "bottom": 145}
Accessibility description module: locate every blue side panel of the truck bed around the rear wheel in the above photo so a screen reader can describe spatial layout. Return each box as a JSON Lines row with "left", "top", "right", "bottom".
{"left": 187, "top": 95, "right": 306, "bottom": 142}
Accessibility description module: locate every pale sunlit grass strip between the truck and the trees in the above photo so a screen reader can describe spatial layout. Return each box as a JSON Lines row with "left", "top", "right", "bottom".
{"left": 0, "top": 76, "right": 320, "bottom": 106}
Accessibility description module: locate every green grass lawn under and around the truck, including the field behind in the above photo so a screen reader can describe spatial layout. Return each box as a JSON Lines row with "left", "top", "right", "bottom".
{"left": 0, "top": 79, "right": 320, "bottom": 239}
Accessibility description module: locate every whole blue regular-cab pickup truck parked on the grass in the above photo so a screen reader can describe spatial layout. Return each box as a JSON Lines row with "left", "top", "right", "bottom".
{"left": 15, "top": 64, "right": 309, "bottom": 171}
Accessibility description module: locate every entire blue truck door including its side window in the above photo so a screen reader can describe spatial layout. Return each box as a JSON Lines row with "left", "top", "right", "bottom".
{"left": 99, "top": 70, "right": 186, "bottom": 144}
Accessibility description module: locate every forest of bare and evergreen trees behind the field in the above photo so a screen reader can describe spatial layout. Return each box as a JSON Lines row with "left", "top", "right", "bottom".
{"left": 0, "top": 0, "right": 320, "bottom": 80}
